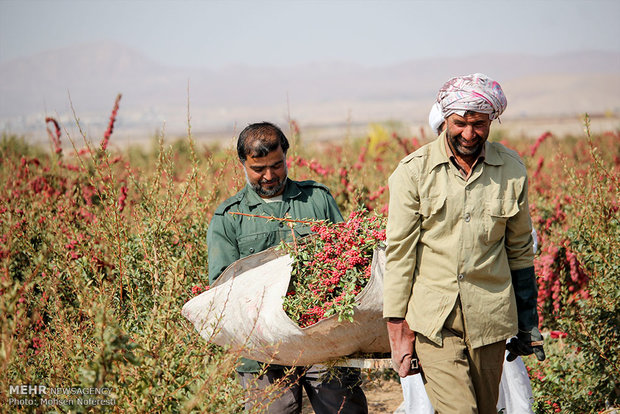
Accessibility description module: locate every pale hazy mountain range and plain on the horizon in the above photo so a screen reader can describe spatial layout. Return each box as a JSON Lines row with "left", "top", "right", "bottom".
{"left": 0, "top": 42, "right": 620, "bottom": 141}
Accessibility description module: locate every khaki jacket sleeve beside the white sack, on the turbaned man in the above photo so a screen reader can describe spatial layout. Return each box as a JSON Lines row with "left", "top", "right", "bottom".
{"left": 383, "top": 164, "right": 420, "bottom": 318}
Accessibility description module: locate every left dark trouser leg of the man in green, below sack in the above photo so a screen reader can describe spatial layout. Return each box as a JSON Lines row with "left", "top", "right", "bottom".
{"left": 237, "top": 368, "right": 305, "bottom": 414}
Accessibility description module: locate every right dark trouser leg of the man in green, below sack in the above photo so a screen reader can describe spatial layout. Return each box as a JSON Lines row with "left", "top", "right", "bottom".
{"left": 303, "top": 365, "right": 368, "bottom": 414}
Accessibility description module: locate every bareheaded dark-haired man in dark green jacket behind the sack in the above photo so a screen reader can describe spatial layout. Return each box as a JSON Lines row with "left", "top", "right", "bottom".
{"left": 207, "top": 122, "right": 368, "bottom": 414}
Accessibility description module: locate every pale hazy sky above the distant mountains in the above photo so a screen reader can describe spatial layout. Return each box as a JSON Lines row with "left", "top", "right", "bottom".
{"left": 0, "top": 0, "right": 620, "bottom": 68}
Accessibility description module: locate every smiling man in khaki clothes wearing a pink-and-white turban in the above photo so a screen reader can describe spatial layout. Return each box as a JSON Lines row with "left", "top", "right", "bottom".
{"left": 383, "top": 73, "right": 545, "bottom": 414}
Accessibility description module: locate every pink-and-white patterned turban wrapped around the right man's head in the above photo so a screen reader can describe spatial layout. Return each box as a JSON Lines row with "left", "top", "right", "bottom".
{"left": 437, "top": 73, "right": 507, "bottom": 120}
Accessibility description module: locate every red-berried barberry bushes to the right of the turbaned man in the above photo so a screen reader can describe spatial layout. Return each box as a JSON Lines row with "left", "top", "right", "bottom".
{"left": 526, "top": 118, "right": 620, "bottom": 413}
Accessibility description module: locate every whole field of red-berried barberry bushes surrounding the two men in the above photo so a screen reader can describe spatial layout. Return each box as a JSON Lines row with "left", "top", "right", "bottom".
{"left": 0, "top": 101, "right": 620, "bottom": 413}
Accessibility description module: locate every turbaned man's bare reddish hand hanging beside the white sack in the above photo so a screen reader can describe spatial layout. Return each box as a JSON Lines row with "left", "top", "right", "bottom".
{"left": 387, "top": 318, "right": 420, "bottom": 378}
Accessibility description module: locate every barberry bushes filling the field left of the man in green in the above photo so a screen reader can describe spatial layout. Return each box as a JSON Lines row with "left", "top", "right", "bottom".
{"left": 0, "top": 101, "right": 252, "bottom": 413}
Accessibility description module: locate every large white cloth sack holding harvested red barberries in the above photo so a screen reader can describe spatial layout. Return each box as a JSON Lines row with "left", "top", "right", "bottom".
{"left": 182, "top": 248, "right": 390, "bottom": 365}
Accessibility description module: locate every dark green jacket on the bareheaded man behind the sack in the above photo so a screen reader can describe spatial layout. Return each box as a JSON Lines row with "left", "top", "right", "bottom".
{"left": 207, "top": 179, "right": 343, "bottom": 372}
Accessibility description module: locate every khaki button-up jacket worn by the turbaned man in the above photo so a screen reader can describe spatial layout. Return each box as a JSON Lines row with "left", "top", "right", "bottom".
{"left": 383, "top": 133, "right": 535, "bottom": 348}
